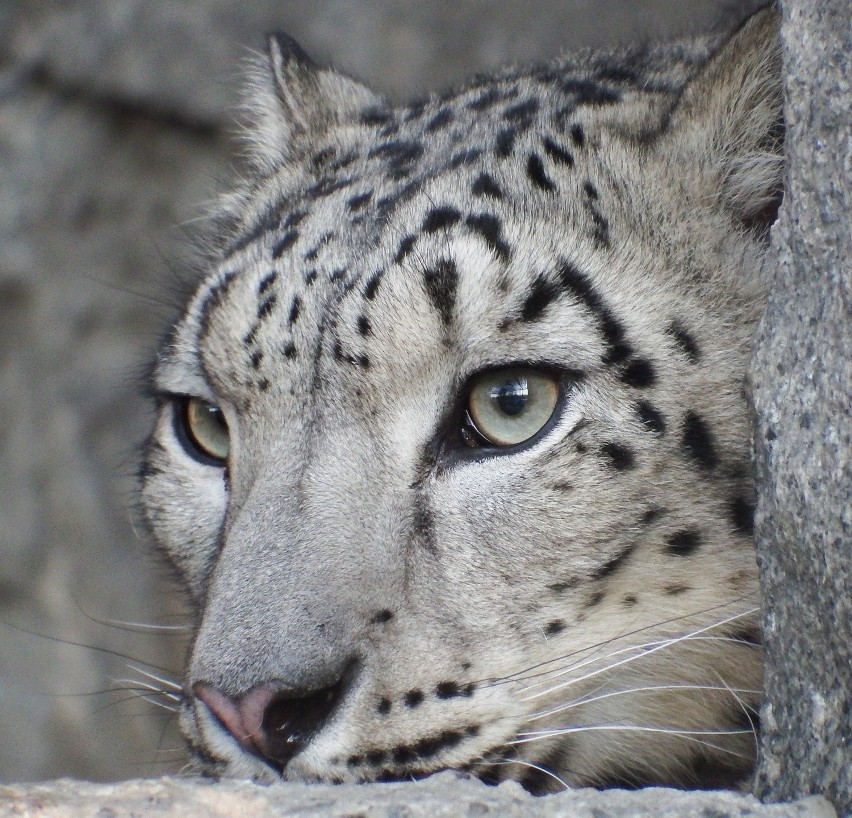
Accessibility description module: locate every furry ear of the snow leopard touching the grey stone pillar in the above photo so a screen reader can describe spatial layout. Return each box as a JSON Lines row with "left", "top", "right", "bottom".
{"left": 664, "top": 7, "right": 784, "bottom": 233}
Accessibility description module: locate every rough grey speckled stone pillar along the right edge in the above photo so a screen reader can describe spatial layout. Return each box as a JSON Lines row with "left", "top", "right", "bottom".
{"left": 753, "top": 0, "right": 852, "bottom": 813}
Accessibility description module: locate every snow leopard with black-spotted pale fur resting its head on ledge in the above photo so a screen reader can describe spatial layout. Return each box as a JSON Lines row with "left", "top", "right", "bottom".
{"left": 141, "top": 6, "right": 783, "bottom": 793}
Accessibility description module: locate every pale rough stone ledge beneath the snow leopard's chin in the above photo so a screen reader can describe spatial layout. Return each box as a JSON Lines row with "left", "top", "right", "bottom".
{"left": 0, "top": 773, "right": 837, "bottom": 818}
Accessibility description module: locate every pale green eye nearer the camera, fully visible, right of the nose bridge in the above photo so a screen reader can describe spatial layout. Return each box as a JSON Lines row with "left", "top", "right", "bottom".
{"left": 464, "top": 367, "right": 559, "bottom": 446}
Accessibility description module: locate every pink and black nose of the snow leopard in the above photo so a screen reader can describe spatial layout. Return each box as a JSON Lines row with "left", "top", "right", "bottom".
{"left": 192, "top": 682, "right": 344, "bottom": 770}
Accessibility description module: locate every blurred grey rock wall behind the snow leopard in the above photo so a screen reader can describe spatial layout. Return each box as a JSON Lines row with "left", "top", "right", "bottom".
{"left": 0, "top": 0, "right": 759, "bottom": 781}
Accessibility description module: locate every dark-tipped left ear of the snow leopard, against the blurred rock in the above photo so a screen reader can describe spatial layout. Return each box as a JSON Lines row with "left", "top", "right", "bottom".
{"left": 243, "top": 32, "right": 387, "bottom": 170}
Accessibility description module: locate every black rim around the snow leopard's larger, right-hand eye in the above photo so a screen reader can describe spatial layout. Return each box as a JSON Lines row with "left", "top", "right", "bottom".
{"left": 441, "top": 361, "right": 584, "bottom": 461}
